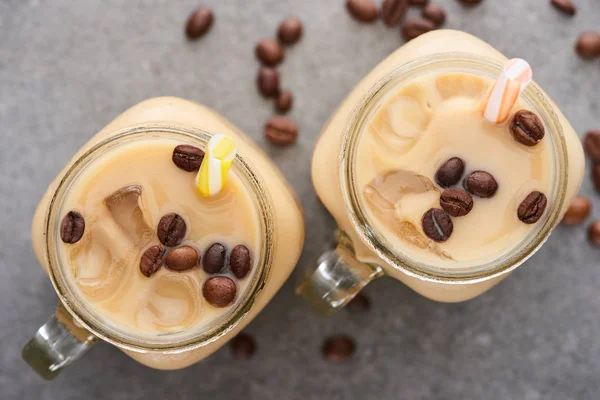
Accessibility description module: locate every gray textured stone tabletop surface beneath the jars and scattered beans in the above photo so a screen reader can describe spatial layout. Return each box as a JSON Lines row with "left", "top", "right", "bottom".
{"left": 0, "top": 0, "right": 600, "bottom": 400}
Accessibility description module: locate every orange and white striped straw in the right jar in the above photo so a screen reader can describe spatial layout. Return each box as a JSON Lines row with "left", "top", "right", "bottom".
{"left": 483, "top": 58, "right": 533, "bottom": 124}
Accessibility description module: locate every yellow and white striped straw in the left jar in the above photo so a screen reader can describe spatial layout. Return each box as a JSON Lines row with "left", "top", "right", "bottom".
{"left": 196, "top": 134, "right": 236, "bottom": 197}
